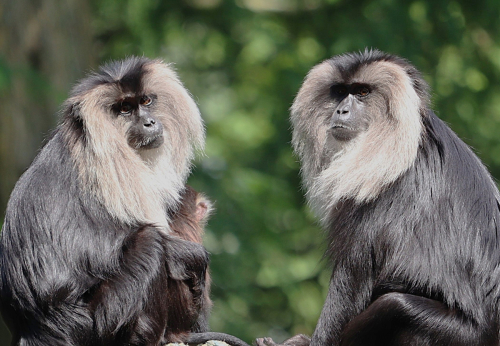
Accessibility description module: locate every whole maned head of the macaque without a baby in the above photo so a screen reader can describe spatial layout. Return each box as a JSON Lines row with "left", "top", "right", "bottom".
{"left": 291, "top": 50, "right": 428, "bottom": 222}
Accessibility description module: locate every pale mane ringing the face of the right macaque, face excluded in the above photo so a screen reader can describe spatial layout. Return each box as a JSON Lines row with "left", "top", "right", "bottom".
{"left": 291, "top": 55, "right": 427, "bottom": 222}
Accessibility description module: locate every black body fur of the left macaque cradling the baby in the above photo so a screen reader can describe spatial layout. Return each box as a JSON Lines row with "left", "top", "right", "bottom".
{"left": 0, "top": 59, "right": 209, "bottom": 346}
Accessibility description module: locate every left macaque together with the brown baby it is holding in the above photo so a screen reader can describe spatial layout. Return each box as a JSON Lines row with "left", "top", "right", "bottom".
{"left": 0, "top": 58, "right": 248, "bottom": 346}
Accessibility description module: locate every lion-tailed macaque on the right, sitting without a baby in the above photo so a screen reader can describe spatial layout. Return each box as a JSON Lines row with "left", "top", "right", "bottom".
{"left": 257, "top": 50, "right": 500, "bottom": 346}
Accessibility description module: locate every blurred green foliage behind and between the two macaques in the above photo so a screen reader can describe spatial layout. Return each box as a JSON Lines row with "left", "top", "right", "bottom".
{"left": 0, "top": 0, "right": 500, "bottom": 341}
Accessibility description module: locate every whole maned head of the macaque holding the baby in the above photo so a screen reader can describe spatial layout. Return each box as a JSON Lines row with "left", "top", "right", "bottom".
{"left": 61, "top": 57, "right": 205, "bottom": 227}
